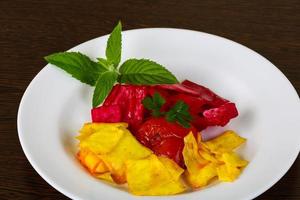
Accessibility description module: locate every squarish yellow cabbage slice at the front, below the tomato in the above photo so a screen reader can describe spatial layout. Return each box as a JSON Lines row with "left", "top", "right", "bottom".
{"left": 126, "top": 154, "right": 186, "bottom": 196}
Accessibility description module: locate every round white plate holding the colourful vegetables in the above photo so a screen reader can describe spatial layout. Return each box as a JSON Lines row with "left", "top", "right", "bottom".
{"left": 18, "top": 28, "right": 300, "bottom": 200}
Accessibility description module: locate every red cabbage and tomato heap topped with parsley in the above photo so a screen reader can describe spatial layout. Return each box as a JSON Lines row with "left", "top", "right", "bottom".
{"left": 91, "top": 80, "right": 238, "bottom": 166}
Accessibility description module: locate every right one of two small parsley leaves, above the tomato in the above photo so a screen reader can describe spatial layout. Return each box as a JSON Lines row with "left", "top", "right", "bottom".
{"left": 166, "top": 101, "right": 192, "bottom": 128}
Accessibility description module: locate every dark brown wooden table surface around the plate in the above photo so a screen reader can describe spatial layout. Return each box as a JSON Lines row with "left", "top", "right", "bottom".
{"left": 0, "top": 0, "right": 300, "bottom": 200}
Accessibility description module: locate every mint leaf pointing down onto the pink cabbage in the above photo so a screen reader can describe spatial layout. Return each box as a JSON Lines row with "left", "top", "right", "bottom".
{"left": 93, "top": 71, "right": 118, "bottom": 107}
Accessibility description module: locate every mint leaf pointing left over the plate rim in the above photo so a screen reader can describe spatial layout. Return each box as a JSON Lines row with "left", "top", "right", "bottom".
{"left": 45, "top": 52, "right": 107, "bottom": 86}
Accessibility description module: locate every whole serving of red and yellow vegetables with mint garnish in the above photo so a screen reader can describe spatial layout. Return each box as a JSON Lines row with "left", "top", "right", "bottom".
{"left": 45, "top": 23, "right": 248, "bottom": 196}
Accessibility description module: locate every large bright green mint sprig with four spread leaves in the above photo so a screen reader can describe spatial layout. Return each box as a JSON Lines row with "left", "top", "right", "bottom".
{"left": 45, "top": 22, "right": 178, "bottom": 107}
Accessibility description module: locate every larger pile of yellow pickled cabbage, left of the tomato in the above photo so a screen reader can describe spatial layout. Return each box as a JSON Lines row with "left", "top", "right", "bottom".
{"left": 77, "top": 123, "right": 186, "bottom": 195}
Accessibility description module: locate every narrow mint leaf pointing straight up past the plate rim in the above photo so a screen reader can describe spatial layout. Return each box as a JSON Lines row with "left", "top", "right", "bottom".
{"left": 105, "top": 22, "right": 122, "bottom": 68}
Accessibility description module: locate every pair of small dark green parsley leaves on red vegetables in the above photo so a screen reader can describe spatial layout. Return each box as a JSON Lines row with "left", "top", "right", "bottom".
{"left": 142, "top": 92, "right": 192, "bottom": 128}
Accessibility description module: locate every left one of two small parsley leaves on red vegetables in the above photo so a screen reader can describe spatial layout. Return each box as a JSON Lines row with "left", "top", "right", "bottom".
{"left": 142, "top": 92, "right": 166, "bottom": 117}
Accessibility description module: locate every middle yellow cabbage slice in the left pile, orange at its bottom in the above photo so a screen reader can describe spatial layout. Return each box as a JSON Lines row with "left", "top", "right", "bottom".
{"left": 100, "top": 127, "right": 152, "bottom": 184}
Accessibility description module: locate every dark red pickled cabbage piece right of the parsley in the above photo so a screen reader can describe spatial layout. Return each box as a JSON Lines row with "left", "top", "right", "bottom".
{"left": 157, "top": 80, "right": 238, "bottom": 131}
